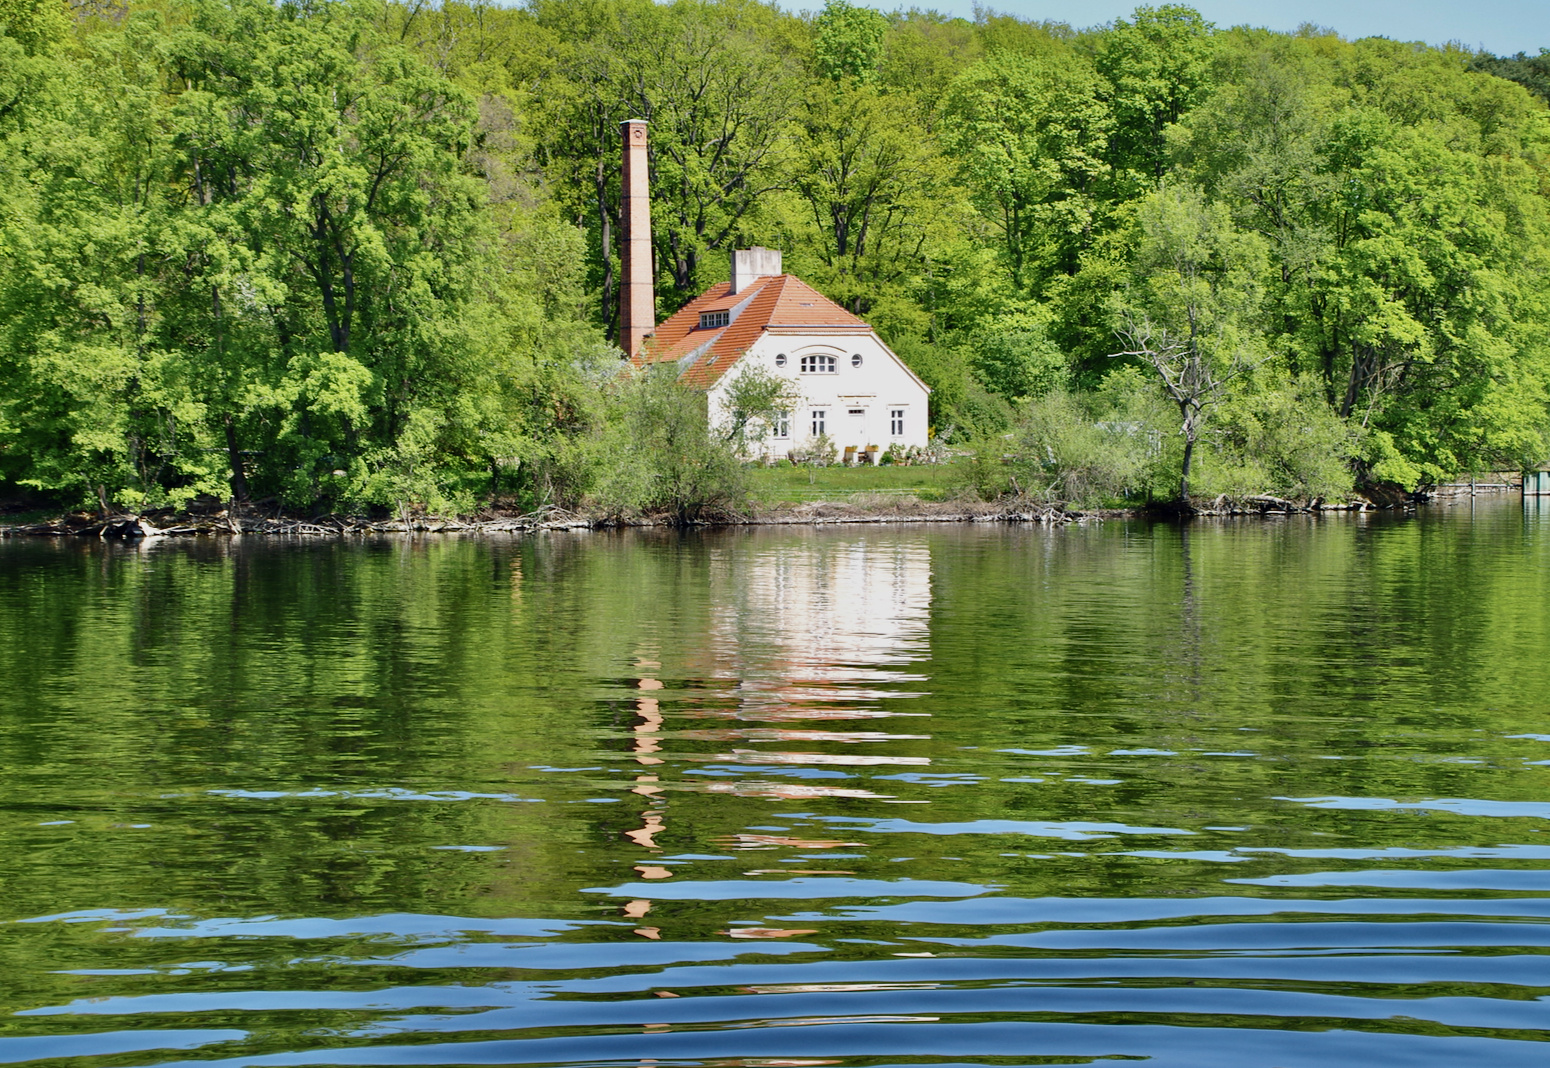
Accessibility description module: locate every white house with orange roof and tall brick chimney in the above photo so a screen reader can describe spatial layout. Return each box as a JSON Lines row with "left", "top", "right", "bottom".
{"left": 620, "top": 121, "right": 930, "bottom": 457}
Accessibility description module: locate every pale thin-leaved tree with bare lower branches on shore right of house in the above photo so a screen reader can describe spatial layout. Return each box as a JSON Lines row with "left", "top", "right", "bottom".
{"left": 1113, "top": 186, "right": 1268, "bottom": 507}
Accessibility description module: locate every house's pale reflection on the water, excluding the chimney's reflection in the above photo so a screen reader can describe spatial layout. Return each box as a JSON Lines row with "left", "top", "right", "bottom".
{"left": 651, "top": 532, "right": 932, "bottom": 798}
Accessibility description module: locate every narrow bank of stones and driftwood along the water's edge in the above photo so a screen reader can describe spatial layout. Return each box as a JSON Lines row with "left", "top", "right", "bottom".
{"left": 0, "top": 487, "right": 1481, "bottom": 541}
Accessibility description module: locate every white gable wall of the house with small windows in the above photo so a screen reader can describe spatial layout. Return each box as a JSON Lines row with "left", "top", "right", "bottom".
{"left": 710, "top": 333, "right": 928, "bottom": 457}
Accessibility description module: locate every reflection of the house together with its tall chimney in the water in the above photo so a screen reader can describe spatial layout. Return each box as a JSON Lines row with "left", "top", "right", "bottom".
{"left": 623, "top": 533, "right": 932, "bottom": 917}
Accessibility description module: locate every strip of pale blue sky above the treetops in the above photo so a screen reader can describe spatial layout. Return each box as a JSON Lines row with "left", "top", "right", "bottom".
{"left": 837, "top": 0, "right": 1550, "bottom": 56}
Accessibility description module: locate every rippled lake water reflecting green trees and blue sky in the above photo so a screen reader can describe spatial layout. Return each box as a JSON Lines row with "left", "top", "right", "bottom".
{"left": 0, "top": 501, "right": 1550, "bottom": 1068}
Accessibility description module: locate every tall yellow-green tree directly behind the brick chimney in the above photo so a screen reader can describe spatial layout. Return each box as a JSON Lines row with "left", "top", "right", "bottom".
{"left": 532, "top": 0, "right": 800, "bottom": 322}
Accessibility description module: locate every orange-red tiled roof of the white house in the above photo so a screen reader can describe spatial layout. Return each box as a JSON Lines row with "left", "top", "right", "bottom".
{"left": 634, "top": 274, "right": 871, "bottom": 389}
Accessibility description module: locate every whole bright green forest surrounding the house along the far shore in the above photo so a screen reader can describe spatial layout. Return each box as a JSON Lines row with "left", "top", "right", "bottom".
{"left": 0, "top": 0, "right": 1550, "bottom": 513}
